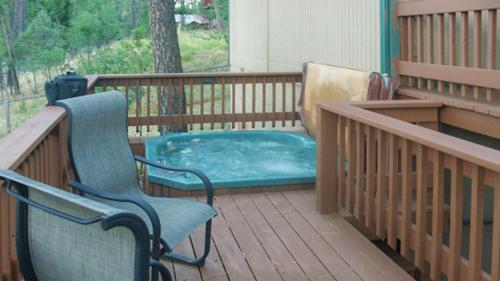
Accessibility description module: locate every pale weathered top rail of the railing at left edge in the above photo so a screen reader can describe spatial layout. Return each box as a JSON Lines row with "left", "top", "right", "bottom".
{"left": 0, "top": 106, "right": 66, "bottom": 169}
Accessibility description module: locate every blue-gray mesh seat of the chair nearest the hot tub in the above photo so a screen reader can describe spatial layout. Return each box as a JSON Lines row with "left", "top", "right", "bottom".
{"left": 102, "top": 193, "right": 217, "bottom": 248}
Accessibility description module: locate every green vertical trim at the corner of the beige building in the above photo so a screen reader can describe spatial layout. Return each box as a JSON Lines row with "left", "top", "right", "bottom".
{"left": 380, "top": 0, "right": 400, "bottom": 76}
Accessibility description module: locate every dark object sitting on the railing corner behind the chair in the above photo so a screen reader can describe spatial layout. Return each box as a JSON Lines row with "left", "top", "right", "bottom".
{"left": 45, "top": 71, "right": 88, "bottom": 105}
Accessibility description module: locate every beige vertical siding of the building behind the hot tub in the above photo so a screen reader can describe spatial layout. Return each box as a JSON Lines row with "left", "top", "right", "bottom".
{"left": 230, "top": 0, "right": 380, "bottom": 71}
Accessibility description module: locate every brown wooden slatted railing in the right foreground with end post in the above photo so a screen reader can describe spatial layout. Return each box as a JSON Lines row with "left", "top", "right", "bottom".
{"left": 316, "top": 101, "right": 500, "bottom": 281}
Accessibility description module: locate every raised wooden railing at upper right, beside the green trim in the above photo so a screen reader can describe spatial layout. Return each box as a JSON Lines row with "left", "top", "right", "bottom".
{"left": 396, "top": 0, "right": 500, "bottom": 106}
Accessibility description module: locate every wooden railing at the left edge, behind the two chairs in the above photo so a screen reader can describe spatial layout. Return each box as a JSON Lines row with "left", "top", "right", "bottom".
{"left": 0, "top": 106, "right": 72, "bottom": 281}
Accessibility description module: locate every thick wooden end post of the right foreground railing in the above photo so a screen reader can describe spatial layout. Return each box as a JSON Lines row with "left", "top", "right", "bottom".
{"left": 316, "top": 106, "right": 338, "bottom": 214}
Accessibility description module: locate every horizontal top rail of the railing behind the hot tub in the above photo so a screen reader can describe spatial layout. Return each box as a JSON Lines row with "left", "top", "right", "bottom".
{"left": 89, "top": 72, "right": 302, "bottom": 80}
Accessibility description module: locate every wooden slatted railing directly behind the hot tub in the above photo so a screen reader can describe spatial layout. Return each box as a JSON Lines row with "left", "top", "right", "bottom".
{"left": 91, "top": 72, "right": 302, "bottom": 136}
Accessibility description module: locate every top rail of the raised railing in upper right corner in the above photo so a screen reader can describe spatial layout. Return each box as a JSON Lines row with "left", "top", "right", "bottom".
{"left": 396, "top": 0, "right": 499, "bottom": 17}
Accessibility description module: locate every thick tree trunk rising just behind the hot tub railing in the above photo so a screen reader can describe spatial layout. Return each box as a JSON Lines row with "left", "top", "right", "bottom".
{"left": 148, "top": 0, "right": 186, "bottom": 133}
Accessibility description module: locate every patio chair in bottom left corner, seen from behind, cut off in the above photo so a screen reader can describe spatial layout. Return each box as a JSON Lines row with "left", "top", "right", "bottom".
{"left": 0, "top": 170, "right": 171, "bottom": 281}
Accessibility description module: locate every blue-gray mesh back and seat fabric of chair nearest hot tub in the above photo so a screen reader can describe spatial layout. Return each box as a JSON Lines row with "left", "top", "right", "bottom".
{"left": 57, "top": 91, "right": 216, "bottom": 248}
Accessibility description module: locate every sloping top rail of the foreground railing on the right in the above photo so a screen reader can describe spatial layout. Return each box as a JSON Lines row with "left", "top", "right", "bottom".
{"left": 318, "top": 101, "right": 500, "bottom": 172}
